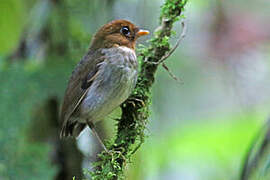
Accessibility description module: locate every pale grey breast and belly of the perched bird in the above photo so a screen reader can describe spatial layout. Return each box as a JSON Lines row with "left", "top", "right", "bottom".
{"left": 80, "top": 46, "right": 138, "bottom": 122}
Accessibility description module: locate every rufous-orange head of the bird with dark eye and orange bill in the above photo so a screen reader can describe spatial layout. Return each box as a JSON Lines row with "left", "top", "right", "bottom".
{"left": 90, "top": 19, "right": 149, "bottom": 50}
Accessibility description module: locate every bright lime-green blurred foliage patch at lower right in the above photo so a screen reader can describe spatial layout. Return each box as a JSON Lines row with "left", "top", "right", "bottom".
{"left": 132, "top": 112, "right": 265, "bottom": 180}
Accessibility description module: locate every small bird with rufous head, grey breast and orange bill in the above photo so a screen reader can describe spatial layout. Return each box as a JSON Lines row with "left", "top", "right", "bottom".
{"left": 60, "top": 19, "right": 149, "bottom": 151}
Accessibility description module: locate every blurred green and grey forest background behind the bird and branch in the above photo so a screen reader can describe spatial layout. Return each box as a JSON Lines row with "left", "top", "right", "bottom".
{"left": 0, "top": 0, "right": 270, "bottom": 180}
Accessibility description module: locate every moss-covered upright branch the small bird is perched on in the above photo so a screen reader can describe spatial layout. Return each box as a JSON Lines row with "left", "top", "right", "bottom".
{"left": 90, "top": 0, "right": 187, "bottom": 180}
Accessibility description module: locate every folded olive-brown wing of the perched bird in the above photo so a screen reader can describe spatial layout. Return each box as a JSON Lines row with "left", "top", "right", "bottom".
{"left": 60, "top": 49, "right": 104, "bottom": 124}
